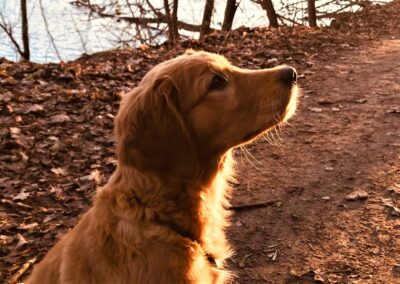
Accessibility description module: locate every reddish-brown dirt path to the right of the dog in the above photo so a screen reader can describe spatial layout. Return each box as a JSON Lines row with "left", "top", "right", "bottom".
{"left": 229, "top": 40, "right": 400, "bottom": 283}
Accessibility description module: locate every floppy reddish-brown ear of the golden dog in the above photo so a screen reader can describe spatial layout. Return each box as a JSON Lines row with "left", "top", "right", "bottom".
{"left": 115, "top": 77, "right": 198, "bottom": 179}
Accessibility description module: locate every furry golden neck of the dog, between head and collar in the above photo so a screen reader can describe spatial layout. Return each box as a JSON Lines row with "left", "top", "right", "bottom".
{"left": 104, "top": 152, "right": 233, "bottom": 247}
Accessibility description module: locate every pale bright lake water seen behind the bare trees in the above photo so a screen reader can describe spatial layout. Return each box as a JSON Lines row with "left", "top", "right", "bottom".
{"left": 0, "top": 0, "right": 388, "bottom": 63}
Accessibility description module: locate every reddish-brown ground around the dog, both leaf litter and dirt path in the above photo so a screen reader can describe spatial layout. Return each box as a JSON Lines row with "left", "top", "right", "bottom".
{"left": 0, "top": 1, "right": 400, "bottom": 284}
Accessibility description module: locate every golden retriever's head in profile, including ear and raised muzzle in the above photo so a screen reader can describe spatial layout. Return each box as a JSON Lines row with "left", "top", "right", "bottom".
{"left": 116, "top": 51, "right": 297, "bottom": 178}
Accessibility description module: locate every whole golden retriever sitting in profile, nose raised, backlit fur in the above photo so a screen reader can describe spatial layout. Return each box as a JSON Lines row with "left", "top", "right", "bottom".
{"left": 27, "top": 51, "right": 297, "bottom": 284}
